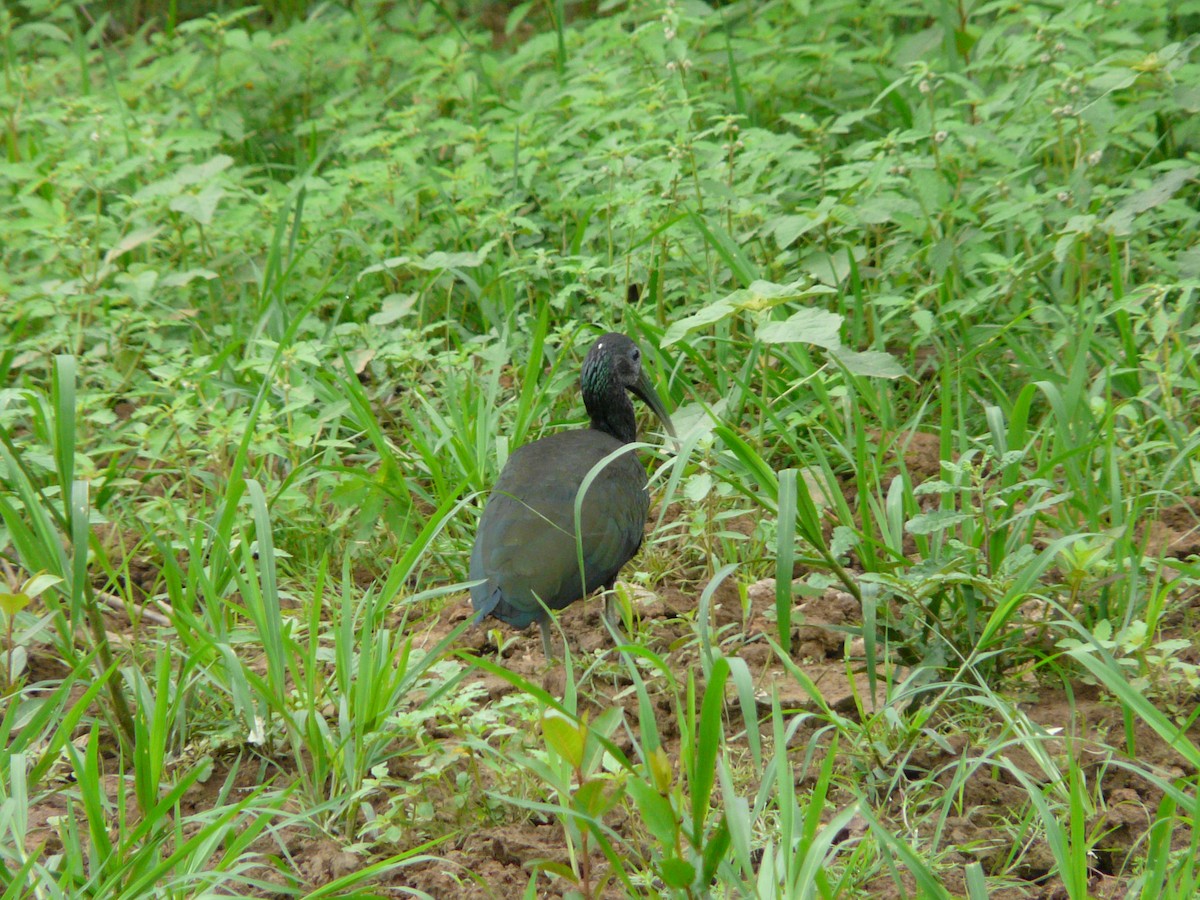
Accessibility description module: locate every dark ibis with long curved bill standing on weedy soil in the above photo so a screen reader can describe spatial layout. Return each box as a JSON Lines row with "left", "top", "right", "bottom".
{"left": 470, "top": 331, "right": 674, "bottom": 661}
